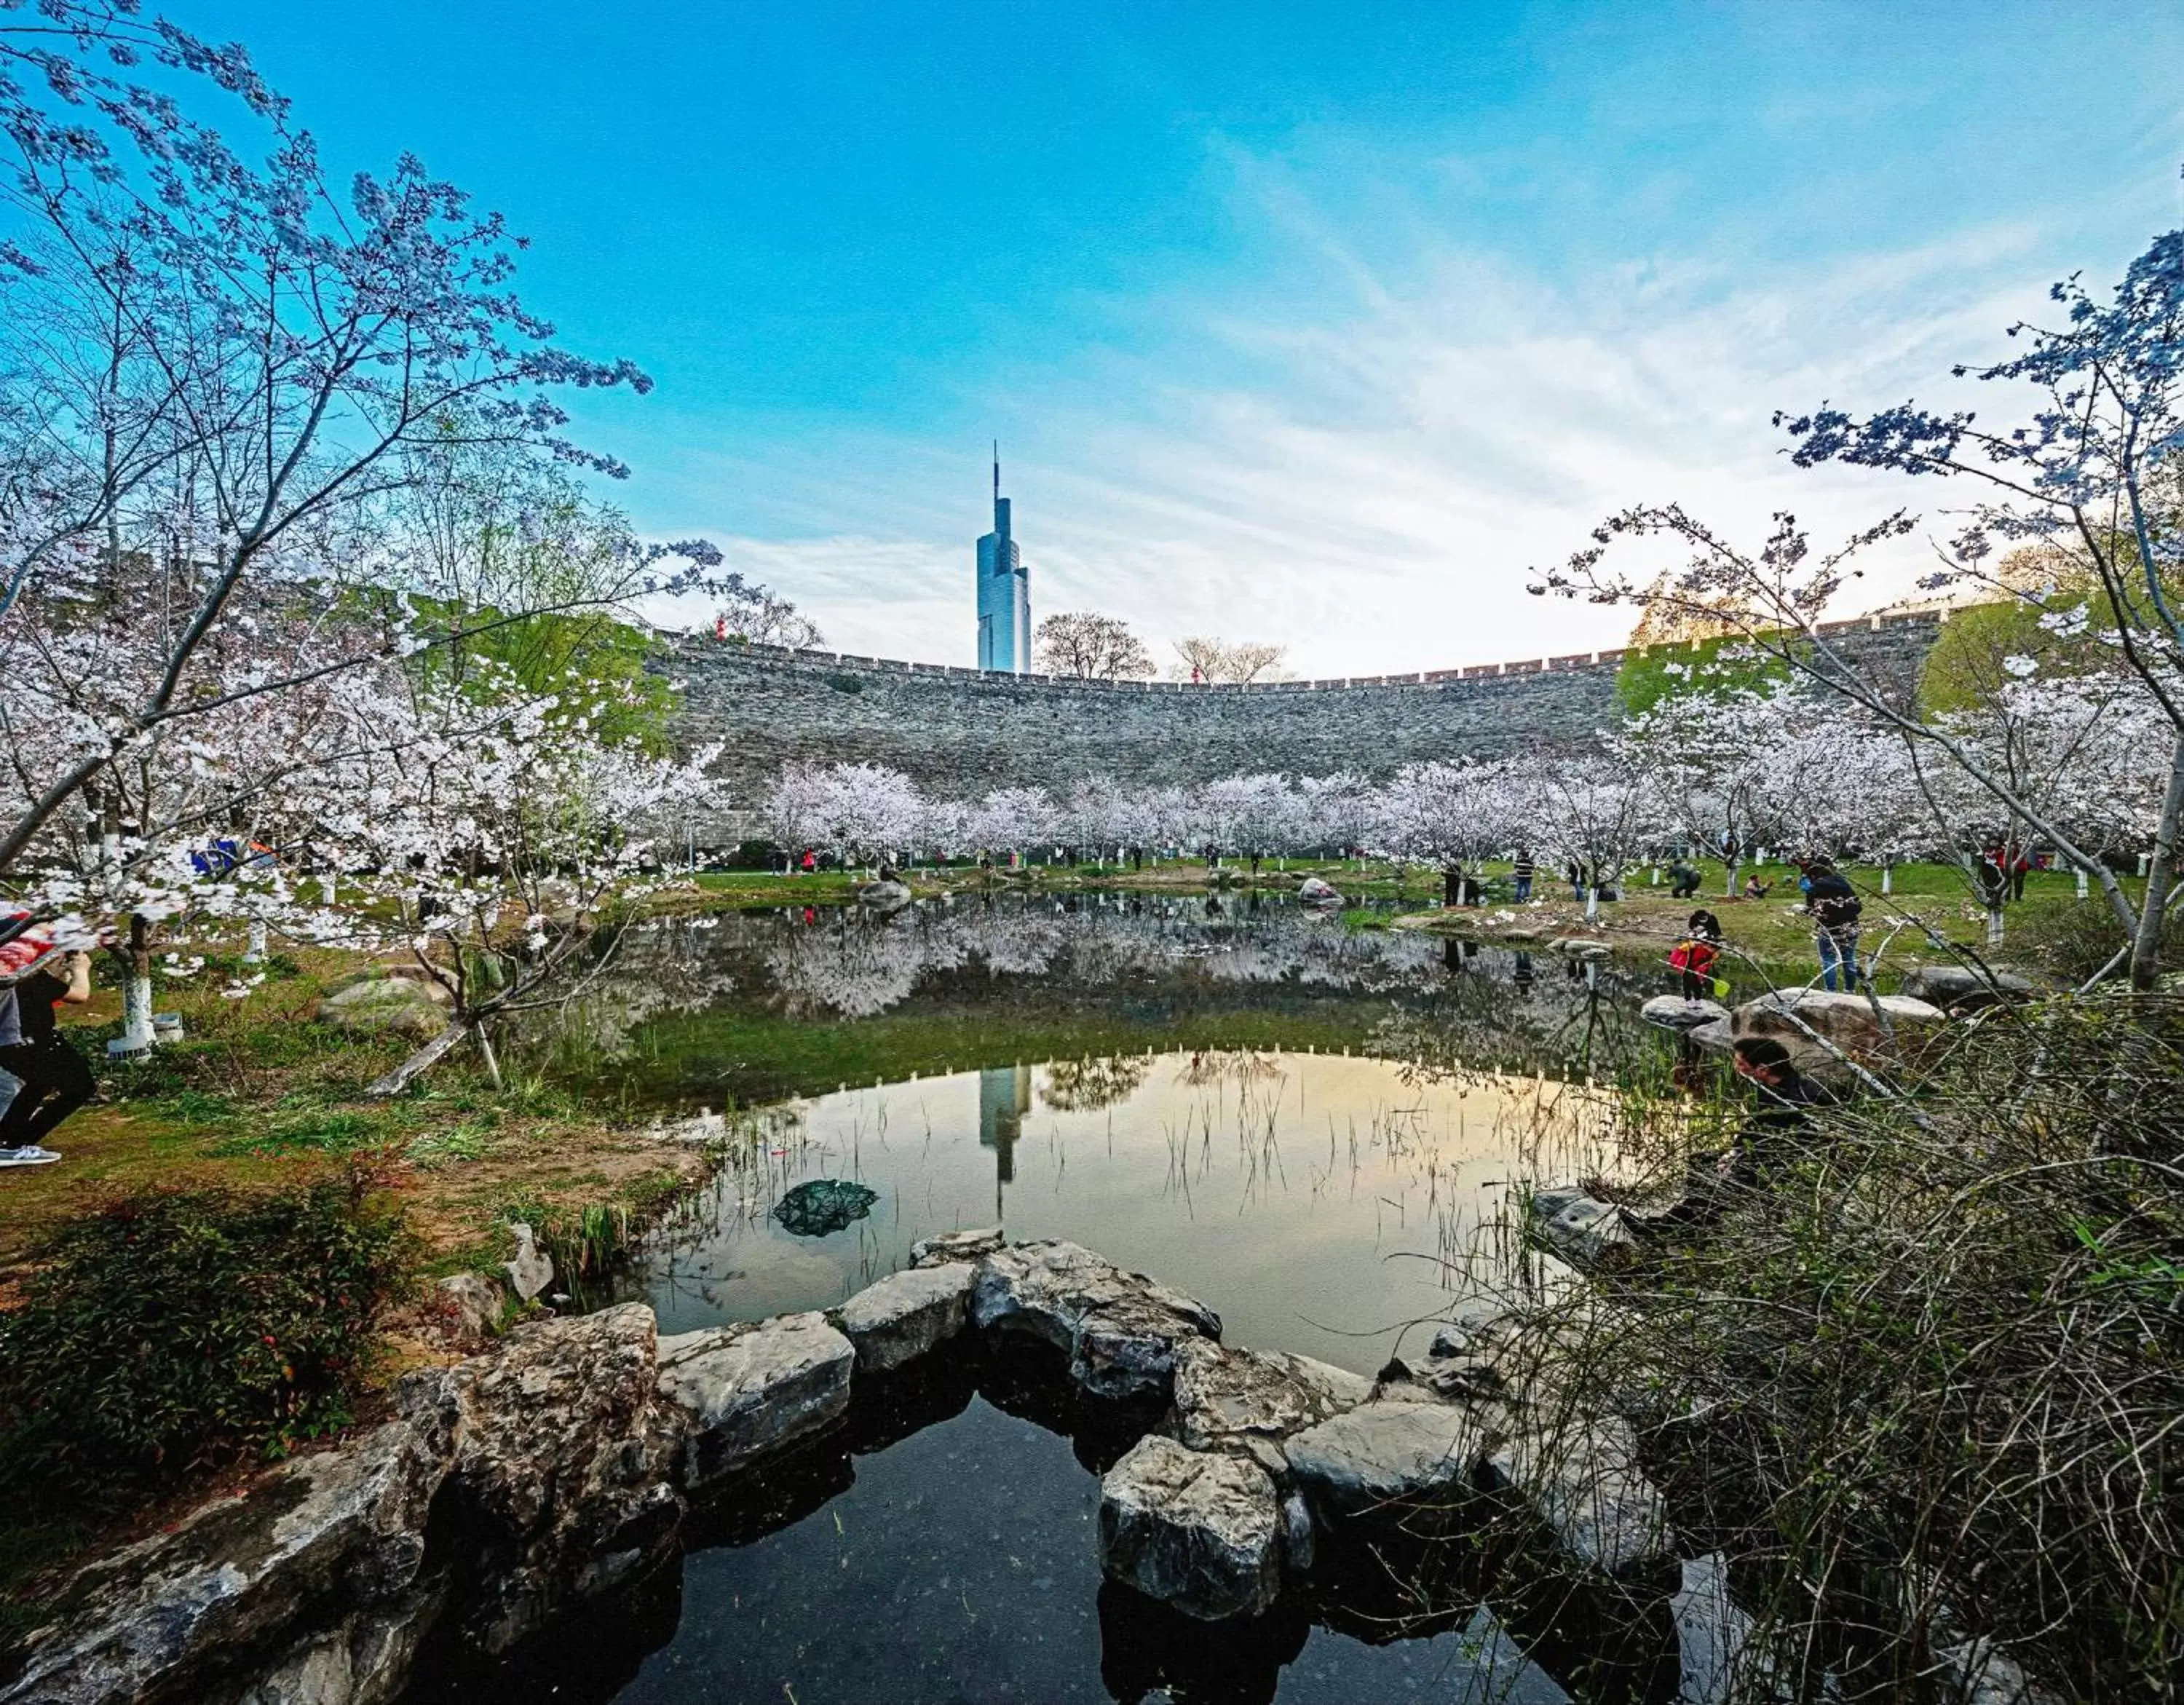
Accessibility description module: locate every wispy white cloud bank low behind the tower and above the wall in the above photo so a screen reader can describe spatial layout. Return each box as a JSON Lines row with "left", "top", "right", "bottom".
{"left": 646, "top": 205, "right": 2079, "bottom": 675}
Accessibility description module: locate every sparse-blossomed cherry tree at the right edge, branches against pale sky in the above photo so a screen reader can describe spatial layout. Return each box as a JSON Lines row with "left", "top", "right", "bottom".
{"left": 1533, "top": 218, "right": 2184, "bottom": 989}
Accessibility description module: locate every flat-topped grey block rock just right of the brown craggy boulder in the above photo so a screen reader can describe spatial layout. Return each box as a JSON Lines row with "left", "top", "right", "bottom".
{"left": 660, "top": 1314, "right": 856, "bottom": 1489}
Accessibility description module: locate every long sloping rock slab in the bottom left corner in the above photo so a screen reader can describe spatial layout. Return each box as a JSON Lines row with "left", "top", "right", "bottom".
{"left": 0, "top": 1421, "right": 448, "bottom": 1705}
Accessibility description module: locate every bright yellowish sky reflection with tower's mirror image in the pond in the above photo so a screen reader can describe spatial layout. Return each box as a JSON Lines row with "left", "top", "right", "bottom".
{"left": 631, "top": 1050, "right": 1618, "bottom": 1373}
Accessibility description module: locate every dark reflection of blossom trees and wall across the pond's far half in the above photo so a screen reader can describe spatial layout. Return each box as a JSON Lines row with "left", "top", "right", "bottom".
{"left": 518, "top": 895, "right": 1666, "bottom": 1113}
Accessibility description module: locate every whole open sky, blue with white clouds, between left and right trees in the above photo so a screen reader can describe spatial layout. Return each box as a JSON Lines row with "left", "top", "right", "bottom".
{"left": 197, "top": 0, "right": 2184, "bottom": 675}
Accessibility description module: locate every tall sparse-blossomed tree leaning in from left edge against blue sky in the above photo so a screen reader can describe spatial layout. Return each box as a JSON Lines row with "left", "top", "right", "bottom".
{"left": 0, "top": 0, "right": 719, "bottom": 869}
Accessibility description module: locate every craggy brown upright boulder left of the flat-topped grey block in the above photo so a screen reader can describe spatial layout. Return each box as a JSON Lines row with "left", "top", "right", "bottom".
{"left": 395, "top": 1303, "right": 684, "bottom": 1653}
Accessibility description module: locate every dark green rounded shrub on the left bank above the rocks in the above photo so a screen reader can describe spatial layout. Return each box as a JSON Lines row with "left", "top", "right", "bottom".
{"left": 0, "top": 1174, "right": 402, "bottom": 1495}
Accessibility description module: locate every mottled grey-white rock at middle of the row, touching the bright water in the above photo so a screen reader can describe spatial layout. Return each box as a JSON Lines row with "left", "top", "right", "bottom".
{"left": 970, "top": 1242, "right": 1221, "bottom": 1397}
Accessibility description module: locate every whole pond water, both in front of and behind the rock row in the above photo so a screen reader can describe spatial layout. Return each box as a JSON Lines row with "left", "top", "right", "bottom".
{"left": 413, "top": 895, "right": 1673, "bottom": 1705}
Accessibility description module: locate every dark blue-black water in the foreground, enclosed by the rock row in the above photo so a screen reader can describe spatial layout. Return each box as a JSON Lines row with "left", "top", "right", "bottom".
{"left": 408, "top": 1360, "right": 1566, "bottom": 1705}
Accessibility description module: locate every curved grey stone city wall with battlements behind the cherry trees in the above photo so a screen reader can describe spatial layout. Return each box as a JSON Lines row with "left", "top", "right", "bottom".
{"left": 657, "top": 616, "right": 1937, "bottom": 808}
